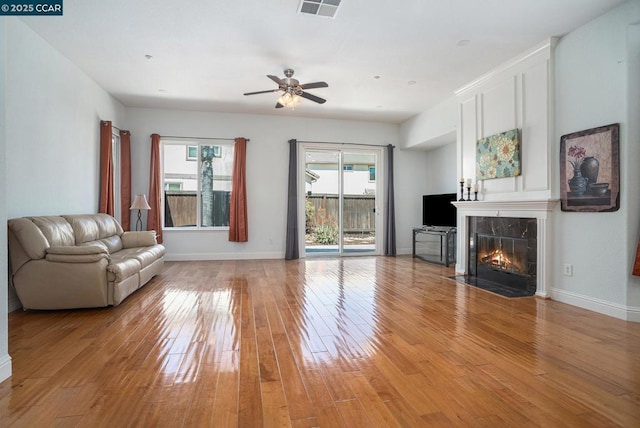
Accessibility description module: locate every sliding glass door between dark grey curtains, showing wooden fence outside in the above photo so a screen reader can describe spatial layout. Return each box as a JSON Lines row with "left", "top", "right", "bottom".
{"left": 302, "top": 146, "right": 381, "bottom": 256}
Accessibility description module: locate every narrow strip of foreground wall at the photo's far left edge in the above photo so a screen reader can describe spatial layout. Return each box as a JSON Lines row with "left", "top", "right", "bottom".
{"left": 0, "top": 16, "right": 11, "bottom": 382}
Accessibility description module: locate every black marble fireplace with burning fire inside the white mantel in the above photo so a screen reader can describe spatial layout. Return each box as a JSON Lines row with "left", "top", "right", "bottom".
{"left": 467, "top": 217, "right": 537, "bottom": 295}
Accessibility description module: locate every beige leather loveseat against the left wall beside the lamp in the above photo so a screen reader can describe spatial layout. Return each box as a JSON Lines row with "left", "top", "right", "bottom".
{"left": 8, "top": 214, "right": 165, "bottom": 309}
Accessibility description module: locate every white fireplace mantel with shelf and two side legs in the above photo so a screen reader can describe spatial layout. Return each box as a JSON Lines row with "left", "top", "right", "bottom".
{"left": 453, "top": 199, "right": 558, "bottom": 298}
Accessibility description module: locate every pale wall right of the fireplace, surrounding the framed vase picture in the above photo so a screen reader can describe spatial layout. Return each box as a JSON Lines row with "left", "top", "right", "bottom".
{"left": 553, "top": 1, "right": 640, "bottom": 321}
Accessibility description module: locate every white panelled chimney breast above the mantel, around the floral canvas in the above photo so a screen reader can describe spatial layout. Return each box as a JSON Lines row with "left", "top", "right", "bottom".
{"left": 456, "top": 40, "right": 557, "bottom": 201}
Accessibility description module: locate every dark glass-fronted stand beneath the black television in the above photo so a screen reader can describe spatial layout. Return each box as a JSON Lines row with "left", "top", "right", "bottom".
{"left": 412, "top": 226, "right": 456, "bottom": 267}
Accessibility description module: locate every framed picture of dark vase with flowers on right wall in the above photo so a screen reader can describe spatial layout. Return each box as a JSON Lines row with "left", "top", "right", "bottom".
{"left": 560, "top": 123, "right": 620, "bottom": 212}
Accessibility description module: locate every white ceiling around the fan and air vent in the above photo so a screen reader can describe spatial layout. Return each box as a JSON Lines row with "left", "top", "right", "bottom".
{"left": 22, "top": 0, "right": 624, "bottom": 123}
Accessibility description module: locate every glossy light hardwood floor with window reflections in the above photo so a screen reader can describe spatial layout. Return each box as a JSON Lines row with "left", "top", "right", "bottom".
{"left": 0, "top": 256, "right": 640, "bottom": 427}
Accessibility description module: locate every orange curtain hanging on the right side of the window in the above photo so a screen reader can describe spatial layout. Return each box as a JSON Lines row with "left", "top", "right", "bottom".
{"left": 229, "top": 138, "right": 249, "bottom": 242}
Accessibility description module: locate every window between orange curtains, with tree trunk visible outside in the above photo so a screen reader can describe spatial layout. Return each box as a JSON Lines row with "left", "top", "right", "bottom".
{"left": 162, "top": 141, "right": 233, "bottom": 229}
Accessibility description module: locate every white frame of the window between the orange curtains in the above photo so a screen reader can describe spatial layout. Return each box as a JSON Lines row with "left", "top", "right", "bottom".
{"left": 160, "top": 138, "right": 235, "bottom": 232}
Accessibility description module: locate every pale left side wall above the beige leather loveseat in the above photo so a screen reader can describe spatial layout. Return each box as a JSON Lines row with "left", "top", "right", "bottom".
{"left": 6, "top": 19, "right": 124, "bottom": 218}
